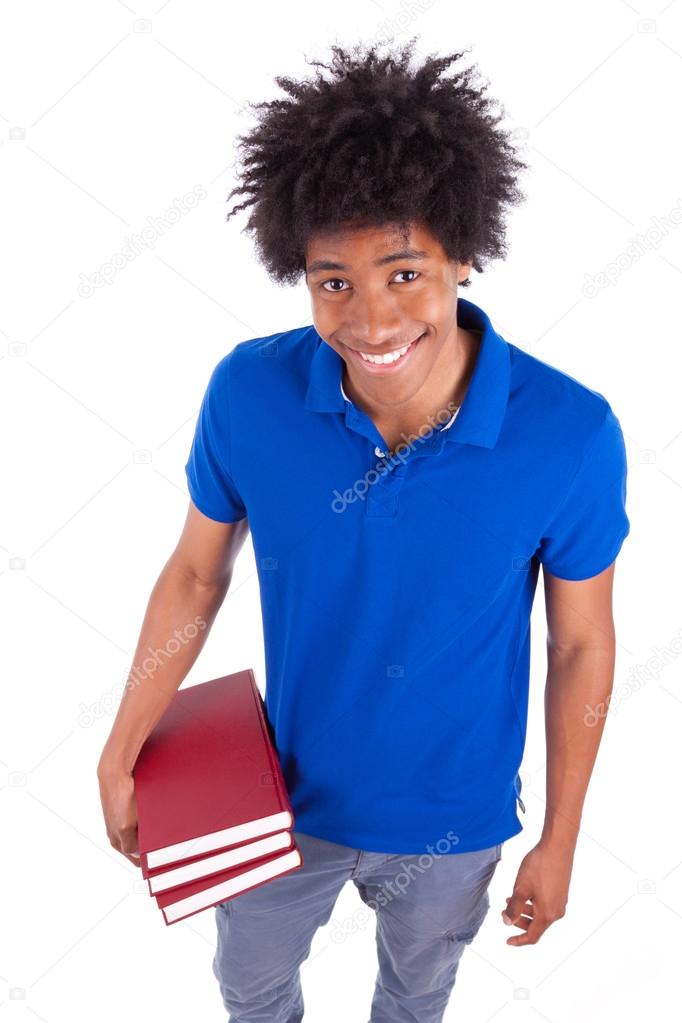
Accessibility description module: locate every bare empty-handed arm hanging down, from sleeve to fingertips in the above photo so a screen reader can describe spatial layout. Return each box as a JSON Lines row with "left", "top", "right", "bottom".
{"left": 503, "top": 563, "right": 616, "bottom": 945}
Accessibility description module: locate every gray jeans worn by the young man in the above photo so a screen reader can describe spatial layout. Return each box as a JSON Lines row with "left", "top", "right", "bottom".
{"left": 213, "top": 832, "right": 502, "bottom": 1023}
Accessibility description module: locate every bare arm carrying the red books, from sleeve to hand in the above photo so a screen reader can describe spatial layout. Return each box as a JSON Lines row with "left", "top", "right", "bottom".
{"left": 97, "top": 501, "right": 248, "bottom": 864}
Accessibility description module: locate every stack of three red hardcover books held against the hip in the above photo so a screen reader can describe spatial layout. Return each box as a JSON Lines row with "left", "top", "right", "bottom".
{"left": 133, "top": 669, "right": 303, "bottom": 925}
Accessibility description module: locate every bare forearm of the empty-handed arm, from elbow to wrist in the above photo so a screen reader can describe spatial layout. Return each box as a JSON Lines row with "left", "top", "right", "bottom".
{"left": 542, "top": 642, "right": 615, "bottom": 847}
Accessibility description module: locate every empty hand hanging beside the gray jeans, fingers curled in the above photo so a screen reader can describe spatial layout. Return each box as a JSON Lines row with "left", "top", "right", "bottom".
{"left": 502, "top": 842, "right": 574, "bottom": 945}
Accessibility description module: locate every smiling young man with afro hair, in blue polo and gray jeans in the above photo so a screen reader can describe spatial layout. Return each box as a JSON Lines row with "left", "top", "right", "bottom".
{"left": 98, "top": 44, "right": 629, "bottom": 1023}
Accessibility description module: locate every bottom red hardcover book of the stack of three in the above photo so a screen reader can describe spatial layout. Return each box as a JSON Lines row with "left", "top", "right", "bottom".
{"left": 155, "top": 845, "right": 303, "bottom": 926}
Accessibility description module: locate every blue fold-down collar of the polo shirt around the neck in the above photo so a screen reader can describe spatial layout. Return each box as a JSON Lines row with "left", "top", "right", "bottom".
{"left": 306, "top": 298, "right": 510, "bottom": 448}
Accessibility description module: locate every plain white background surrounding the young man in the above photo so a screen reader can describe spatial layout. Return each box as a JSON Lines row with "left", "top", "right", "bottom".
{"left": 0, "top": 0, "right": 682, "bottom": 1023}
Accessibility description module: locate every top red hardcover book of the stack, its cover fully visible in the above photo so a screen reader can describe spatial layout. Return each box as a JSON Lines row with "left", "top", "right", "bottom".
{"left": 133, "top": 669, "right": 293, "bottom": 875}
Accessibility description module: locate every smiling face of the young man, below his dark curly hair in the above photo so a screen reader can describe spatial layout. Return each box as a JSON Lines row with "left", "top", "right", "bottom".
{"left": 306, "top": 223, "right": 471, "bottom": 405}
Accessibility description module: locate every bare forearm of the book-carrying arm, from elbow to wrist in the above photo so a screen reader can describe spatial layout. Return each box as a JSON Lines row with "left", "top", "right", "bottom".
{"left": 97, "top": 561, "right": 229, "bottom": 775}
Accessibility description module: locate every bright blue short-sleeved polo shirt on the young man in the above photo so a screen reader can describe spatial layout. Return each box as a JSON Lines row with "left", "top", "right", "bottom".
{"left": 186, "top": 298, "right": 630, "bottom": 854}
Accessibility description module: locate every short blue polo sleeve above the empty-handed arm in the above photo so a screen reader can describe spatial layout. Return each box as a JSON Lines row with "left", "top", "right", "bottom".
{"left": 536, "top": 406, "right": 630, "bottom": 580}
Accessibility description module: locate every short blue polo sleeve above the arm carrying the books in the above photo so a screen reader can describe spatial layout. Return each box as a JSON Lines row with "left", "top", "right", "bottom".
{"left": 185, "top": 355, "right": 246, "bottom": 522}
